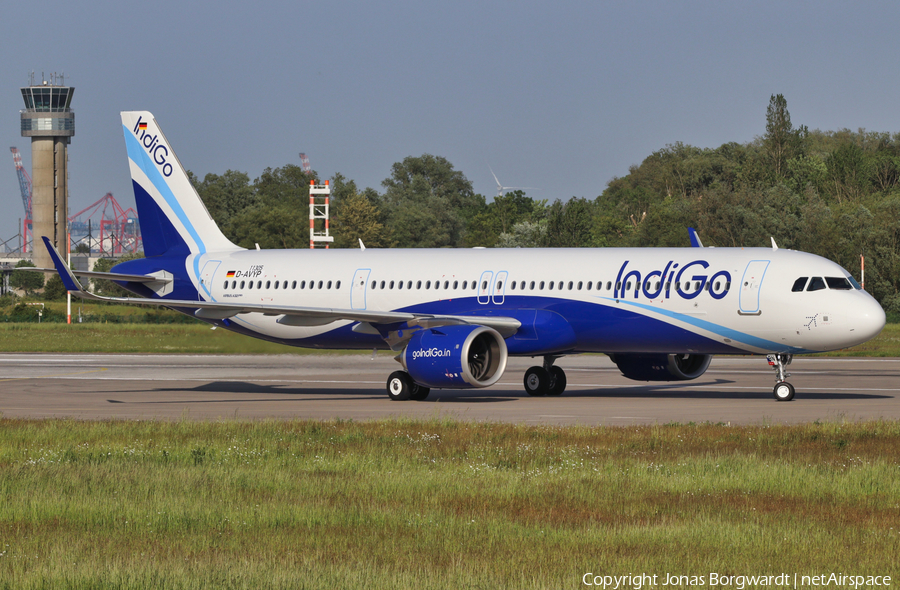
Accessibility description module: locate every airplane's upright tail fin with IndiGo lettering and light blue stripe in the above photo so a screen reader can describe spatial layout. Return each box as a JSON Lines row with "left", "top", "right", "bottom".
{"left": 122, "top": 111, "right": 241, "bottom": 257}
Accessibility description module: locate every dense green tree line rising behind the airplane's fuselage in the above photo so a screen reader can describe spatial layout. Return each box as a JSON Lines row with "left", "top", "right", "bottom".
{"left": 181, "top": 94, "right": 900, "bottom": 312}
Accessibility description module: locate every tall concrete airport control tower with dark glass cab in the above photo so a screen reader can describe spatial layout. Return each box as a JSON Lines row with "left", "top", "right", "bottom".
{"left": 21, "top": 74, "right": 75, "bottom": 268}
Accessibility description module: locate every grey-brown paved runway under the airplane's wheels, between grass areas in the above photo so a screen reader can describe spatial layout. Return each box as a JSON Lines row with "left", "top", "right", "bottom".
{"left": 0, "top": 354, "right": 900, "bottom": 425}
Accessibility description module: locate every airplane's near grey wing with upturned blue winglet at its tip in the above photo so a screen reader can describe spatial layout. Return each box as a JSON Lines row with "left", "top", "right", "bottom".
{"left": 43, "top": 237, "right": 522, "bottom": 338}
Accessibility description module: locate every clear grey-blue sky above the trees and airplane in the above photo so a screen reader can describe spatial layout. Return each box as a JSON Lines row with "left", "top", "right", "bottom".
{"left": 0, "top": 0, "right": 900, "bottom": 249}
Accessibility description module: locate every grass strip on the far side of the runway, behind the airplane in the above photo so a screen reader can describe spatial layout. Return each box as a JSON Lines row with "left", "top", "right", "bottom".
{"left": 0, "top": 322, "right": 900, "bottom": 357}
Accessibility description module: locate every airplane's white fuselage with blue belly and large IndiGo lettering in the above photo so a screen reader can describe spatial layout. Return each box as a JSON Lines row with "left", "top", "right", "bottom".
{"left": 186, "top": 248, "right": 884, "bottom": 354}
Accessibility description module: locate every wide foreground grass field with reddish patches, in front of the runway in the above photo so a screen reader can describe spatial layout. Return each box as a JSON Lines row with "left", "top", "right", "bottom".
{"left": 0, "top": 419, "right": 900, "bottom": 589}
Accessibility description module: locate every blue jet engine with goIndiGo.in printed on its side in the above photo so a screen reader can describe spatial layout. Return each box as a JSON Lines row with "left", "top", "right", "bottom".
{"left": 400, "top": 325, "right": 507, "bottom": 388}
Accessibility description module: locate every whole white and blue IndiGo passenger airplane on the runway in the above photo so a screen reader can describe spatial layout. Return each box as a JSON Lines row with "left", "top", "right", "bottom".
{"left": 44, "top": 111, "right": 886, "bottom": 401}
